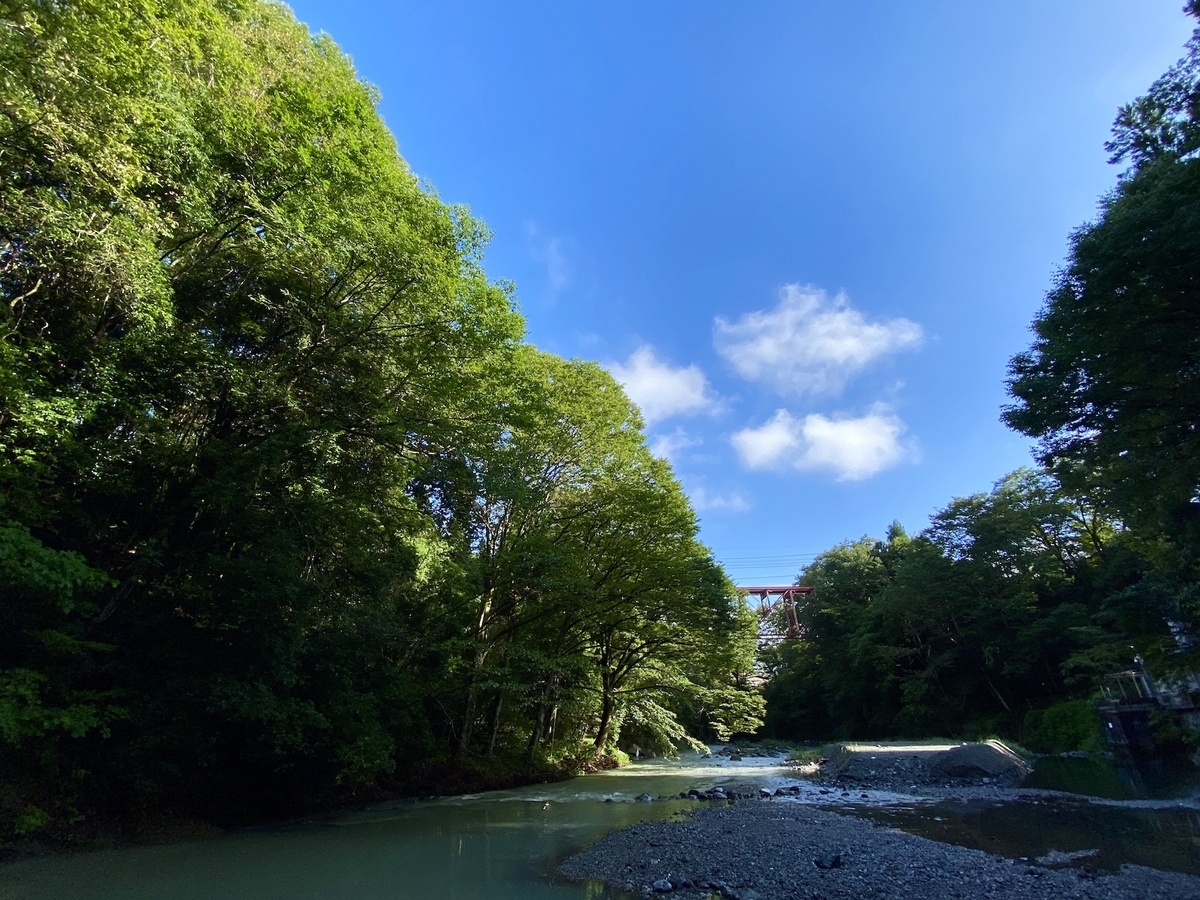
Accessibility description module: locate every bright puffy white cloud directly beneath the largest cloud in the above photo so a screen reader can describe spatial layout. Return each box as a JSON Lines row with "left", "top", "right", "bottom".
{"left": 731, "top": 404, "right": 916, "bottom": 481}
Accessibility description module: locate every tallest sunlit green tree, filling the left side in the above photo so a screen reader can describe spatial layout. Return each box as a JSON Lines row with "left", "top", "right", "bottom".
{"left": 0, "top": 0, "right": 522, "bottom": 820}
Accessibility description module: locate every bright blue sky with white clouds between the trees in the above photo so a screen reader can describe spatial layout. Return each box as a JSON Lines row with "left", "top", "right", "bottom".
{"left": 292, "top": 0, "right": 1192, "bottom": 584}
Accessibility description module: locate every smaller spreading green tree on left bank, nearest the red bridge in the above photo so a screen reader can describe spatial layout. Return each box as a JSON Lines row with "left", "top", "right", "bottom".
{"left": 446, "top": 348, "right": 760, "bottom": 756}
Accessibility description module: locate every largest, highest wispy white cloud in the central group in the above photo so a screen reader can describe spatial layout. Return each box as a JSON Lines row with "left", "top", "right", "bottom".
{"left": 713, "top": 284, "right": 922, "bottom": 394}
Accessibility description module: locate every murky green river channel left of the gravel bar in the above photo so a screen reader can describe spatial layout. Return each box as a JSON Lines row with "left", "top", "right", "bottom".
{"left": 0, "top": 757, "right": 781, "bottom": 900}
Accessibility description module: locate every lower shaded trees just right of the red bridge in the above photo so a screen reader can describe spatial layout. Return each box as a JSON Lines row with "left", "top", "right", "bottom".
{"left": 764, "top": 470, "right": 1175, "bottom": 739}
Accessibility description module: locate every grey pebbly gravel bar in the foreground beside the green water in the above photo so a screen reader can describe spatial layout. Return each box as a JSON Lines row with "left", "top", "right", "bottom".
{"left": 558, "top": 799, "right": 1200, "bottom": 900}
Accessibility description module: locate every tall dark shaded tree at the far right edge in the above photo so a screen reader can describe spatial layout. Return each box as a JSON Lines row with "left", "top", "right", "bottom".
{"left": 1003, "top": 7, "right": 1200, "bottom": 643}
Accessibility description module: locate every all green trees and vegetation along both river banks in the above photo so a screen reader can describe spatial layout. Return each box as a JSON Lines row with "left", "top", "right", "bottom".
{"left": 0, "top": 0, "right": 1200, "bottom": 868}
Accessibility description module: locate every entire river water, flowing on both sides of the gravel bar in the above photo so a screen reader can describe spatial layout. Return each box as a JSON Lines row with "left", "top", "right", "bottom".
{"left": 0, "top": 754, "right": 1200, "bottom": 900}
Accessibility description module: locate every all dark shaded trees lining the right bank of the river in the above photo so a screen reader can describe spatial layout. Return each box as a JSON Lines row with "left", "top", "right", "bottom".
{"left": 764, "top": 4, "right": 1200, "bottom": 739}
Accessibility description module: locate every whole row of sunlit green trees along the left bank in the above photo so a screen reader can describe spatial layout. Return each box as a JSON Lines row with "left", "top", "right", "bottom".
{"left": 0, "top": 0, "right": 762, "bottom": 840}
